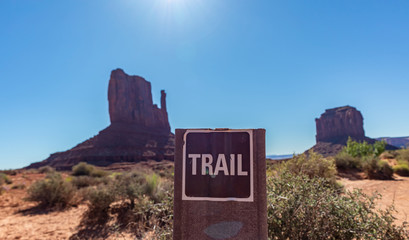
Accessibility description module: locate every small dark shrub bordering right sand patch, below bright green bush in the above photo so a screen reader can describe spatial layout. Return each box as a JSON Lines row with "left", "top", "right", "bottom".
{"left": 363, "top": 156, "right": 393, "bottom": 180}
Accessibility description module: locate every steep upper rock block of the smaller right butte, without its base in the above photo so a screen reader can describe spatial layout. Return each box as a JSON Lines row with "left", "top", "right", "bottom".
{"left": 315, "top": 106, "right": 365, "bottom": 144}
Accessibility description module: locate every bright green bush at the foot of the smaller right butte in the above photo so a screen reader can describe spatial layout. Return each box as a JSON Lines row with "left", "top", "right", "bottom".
{"left": 343, "top": 138, "right": 386, "bottom": 157}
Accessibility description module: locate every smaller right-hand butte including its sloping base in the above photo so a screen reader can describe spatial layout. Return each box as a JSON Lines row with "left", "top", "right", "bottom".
{"left": 312, "top": 106, "right": 397, "bottom": 156}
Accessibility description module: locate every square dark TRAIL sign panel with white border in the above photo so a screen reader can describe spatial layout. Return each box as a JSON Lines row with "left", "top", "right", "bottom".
{"left": 182, "top": 130, "right": 253, "bottom": 201}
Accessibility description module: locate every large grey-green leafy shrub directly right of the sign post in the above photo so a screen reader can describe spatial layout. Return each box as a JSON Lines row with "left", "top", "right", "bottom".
{"left": 267, "top": 172, "right": 408, "bottom": 240}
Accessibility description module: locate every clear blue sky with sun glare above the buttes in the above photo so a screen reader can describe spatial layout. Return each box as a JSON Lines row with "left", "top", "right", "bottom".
{"left": 0, "top": 0, "right": 409, "bottom": 169}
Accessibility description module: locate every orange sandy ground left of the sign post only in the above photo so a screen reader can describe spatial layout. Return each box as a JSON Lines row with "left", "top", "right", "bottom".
{"left": 0, "top": 173, "right": 152, "bottom": 240}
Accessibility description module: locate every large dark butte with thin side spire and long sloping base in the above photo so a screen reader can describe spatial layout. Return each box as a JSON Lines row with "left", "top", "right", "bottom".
{"left": 28, "top": 69, "right": 175, "bottom": 170}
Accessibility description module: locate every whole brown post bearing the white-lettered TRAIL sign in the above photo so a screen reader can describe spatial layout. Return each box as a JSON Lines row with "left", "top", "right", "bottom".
{"left": 173, "top": 129, "right": 267, "bottom": 240}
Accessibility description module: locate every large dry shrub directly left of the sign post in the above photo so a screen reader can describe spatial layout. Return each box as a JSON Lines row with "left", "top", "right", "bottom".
{"left": 86, "top": 172, "right": 173, "bottom": 233}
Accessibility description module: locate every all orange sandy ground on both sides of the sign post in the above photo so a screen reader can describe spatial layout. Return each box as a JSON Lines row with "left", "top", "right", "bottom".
{"left": 0, "top": 170, "right": 409, "bottom": 240}
